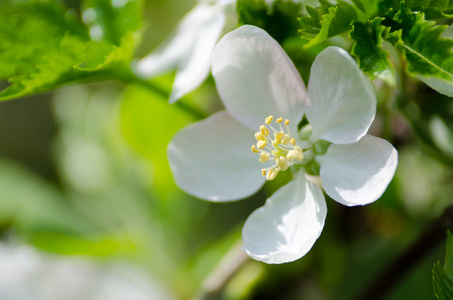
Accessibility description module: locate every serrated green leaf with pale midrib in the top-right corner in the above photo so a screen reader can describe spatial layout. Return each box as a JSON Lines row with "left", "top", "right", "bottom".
{"left": 382, "top": 2, "right": 453, "bottom": 97}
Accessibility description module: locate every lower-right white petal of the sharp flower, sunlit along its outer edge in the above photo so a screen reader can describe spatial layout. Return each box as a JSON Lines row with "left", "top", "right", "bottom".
{"left": 317, "top": 135, "right": 398, "bottom": 206}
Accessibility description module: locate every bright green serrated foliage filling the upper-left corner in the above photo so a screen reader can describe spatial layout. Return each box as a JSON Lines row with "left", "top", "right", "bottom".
{"left": 0, "top": 0, "right": 140, "bottom": 100}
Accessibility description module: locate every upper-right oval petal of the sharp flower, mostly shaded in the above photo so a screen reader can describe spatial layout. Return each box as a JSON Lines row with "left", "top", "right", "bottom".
{"left": 306, "top": 47, "right": 376, "bottom": 144}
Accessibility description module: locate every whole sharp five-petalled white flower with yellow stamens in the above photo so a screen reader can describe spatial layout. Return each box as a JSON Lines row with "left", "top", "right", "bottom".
{"left": 168, "top": 25, "right": 397, "bottom": 263}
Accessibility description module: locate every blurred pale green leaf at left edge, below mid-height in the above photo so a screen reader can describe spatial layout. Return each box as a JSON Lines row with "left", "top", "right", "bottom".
{"left": 0, "top": 160, "right": 93, "bottom": 235}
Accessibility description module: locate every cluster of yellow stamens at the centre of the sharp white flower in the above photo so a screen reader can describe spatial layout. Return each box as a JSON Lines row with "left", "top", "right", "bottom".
{"left": 252, "top": 116, "right": 304, "bottom": 180}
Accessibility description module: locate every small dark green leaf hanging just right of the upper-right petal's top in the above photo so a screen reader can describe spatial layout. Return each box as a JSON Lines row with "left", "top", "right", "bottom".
{"left": 349, "top": 18, "right": 396, "bottom": 86}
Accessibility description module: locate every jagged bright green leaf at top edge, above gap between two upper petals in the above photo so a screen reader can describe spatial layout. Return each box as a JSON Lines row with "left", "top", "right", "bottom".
{"left": 299, "top": 0, "right": 366, "bottom": 48}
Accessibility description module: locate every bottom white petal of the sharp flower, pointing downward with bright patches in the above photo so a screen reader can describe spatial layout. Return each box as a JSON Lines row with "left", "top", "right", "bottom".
{"left": 242, "top": 173, "right": 327, "bottom": 264}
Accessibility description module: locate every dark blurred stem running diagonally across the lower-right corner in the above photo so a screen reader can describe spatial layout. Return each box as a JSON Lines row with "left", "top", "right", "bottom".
{"left": 357, "top": 205, "right": 453, "bottom": 300}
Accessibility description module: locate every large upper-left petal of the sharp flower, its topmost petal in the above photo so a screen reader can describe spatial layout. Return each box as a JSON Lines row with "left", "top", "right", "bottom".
{"left": 212, "top": 25, "right": 307, "bottom": 132}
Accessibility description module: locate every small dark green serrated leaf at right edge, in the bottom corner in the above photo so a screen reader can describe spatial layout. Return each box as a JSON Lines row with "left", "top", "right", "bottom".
{"left": 433, "top": 232, "right": 453, "bottom": 300}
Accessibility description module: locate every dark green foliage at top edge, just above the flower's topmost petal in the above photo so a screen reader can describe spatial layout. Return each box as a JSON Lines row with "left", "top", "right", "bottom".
{"left": 236, "top": 0, "right": 302, "bottom": 43}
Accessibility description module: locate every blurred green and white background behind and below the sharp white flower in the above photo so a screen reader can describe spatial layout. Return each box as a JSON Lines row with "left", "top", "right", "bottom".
{"left": 0, "top": 0, "right": 453, "bottom": 300}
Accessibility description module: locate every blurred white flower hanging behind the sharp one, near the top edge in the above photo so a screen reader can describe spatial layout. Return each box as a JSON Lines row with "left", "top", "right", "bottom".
{"left": 133, "top": 0, "right": 236, "bottom": 103}
